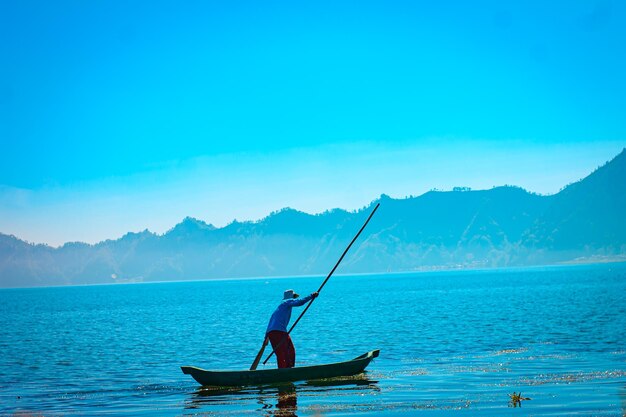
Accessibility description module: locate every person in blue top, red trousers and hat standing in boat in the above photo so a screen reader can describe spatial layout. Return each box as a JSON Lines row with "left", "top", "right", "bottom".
{"left": 264, "top": 290, "right": 318, "bottom": 368}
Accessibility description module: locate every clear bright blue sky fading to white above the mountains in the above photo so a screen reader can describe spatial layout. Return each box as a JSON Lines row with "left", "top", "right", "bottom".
{"left": 0, "top": 0, "right": 626, "bottom": 245}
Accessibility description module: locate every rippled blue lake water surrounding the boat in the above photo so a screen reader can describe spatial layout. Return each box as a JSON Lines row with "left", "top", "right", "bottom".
{"left": 0, "top": 264, "right": 626, "bottom": 416}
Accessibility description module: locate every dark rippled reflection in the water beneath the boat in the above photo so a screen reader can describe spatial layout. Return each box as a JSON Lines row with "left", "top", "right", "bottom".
{"left": 185, "top": 374, "right": 380, "bottom": 417}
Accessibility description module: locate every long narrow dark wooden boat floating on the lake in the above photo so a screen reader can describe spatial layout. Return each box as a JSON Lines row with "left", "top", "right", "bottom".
{"left": 181, "top": 350, "right": 380, "bottom": 387}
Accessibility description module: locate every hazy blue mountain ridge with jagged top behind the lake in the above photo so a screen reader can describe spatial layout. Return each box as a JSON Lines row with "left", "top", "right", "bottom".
{"left": 0, "top": 150, "right": 626, "bottom": 287}
